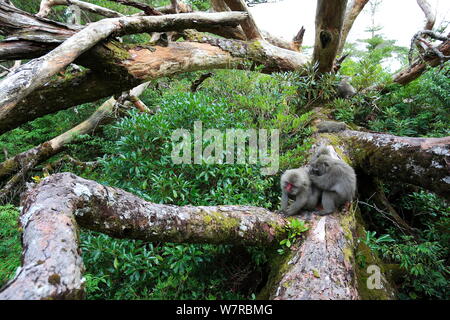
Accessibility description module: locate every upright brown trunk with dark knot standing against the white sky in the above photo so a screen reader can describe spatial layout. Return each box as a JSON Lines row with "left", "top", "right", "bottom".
{"left": 313, "top": 0, "right": 347, "bottom": 73}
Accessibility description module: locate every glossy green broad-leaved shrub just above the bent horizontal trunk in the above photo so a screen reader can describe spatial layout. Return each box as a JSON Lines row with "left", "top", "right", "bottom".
{"left": 100, "top": 93, "right": 273, "bottom": 207}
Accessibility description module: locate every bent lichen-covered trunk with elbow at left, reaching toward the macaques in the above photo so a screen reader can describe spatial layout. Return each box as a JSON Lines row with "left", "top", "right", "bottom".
{"left": 0, "top": 173, "right": 286, "bottom": 300}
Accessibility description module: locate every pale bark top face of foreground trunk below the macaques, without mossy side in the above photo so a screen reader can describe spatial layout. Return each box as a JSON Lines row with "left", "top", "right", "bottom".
{"left": 270, "top": 212, "right": 360, "bottom": 300}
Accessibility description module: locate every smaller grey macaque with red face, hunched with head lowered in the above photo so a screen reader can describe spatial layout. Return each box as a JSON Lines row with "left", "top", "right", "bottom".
{"left": 281, "top": 167, "right": 320, "bottom": 216}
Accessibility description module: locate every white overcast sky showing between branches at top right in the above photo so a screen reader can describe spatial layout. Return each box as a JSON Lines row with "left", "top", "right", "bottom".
{"left": 250, "top": 0, "right": 450, "bottom": 47}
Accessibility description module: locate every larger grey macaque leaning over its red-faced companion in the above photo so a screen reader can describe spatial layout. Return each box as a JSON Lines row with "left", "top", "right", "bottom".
{"left": 309, "top": 147, "right": 356, "bottom": 216}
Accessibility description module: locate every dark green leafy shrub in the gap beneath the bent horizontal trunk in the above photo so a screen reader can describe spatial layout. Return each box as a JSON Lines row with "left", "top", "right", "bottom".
{"left": 81, "top": 232, "right": 266, "bottom": 300}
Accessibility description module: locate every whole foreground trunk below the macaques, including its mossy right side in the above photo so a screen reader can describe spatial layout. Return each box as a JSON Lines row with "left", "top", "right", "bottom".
{"left": 268, "top": 210, "right": 395, "bottom": 300}
